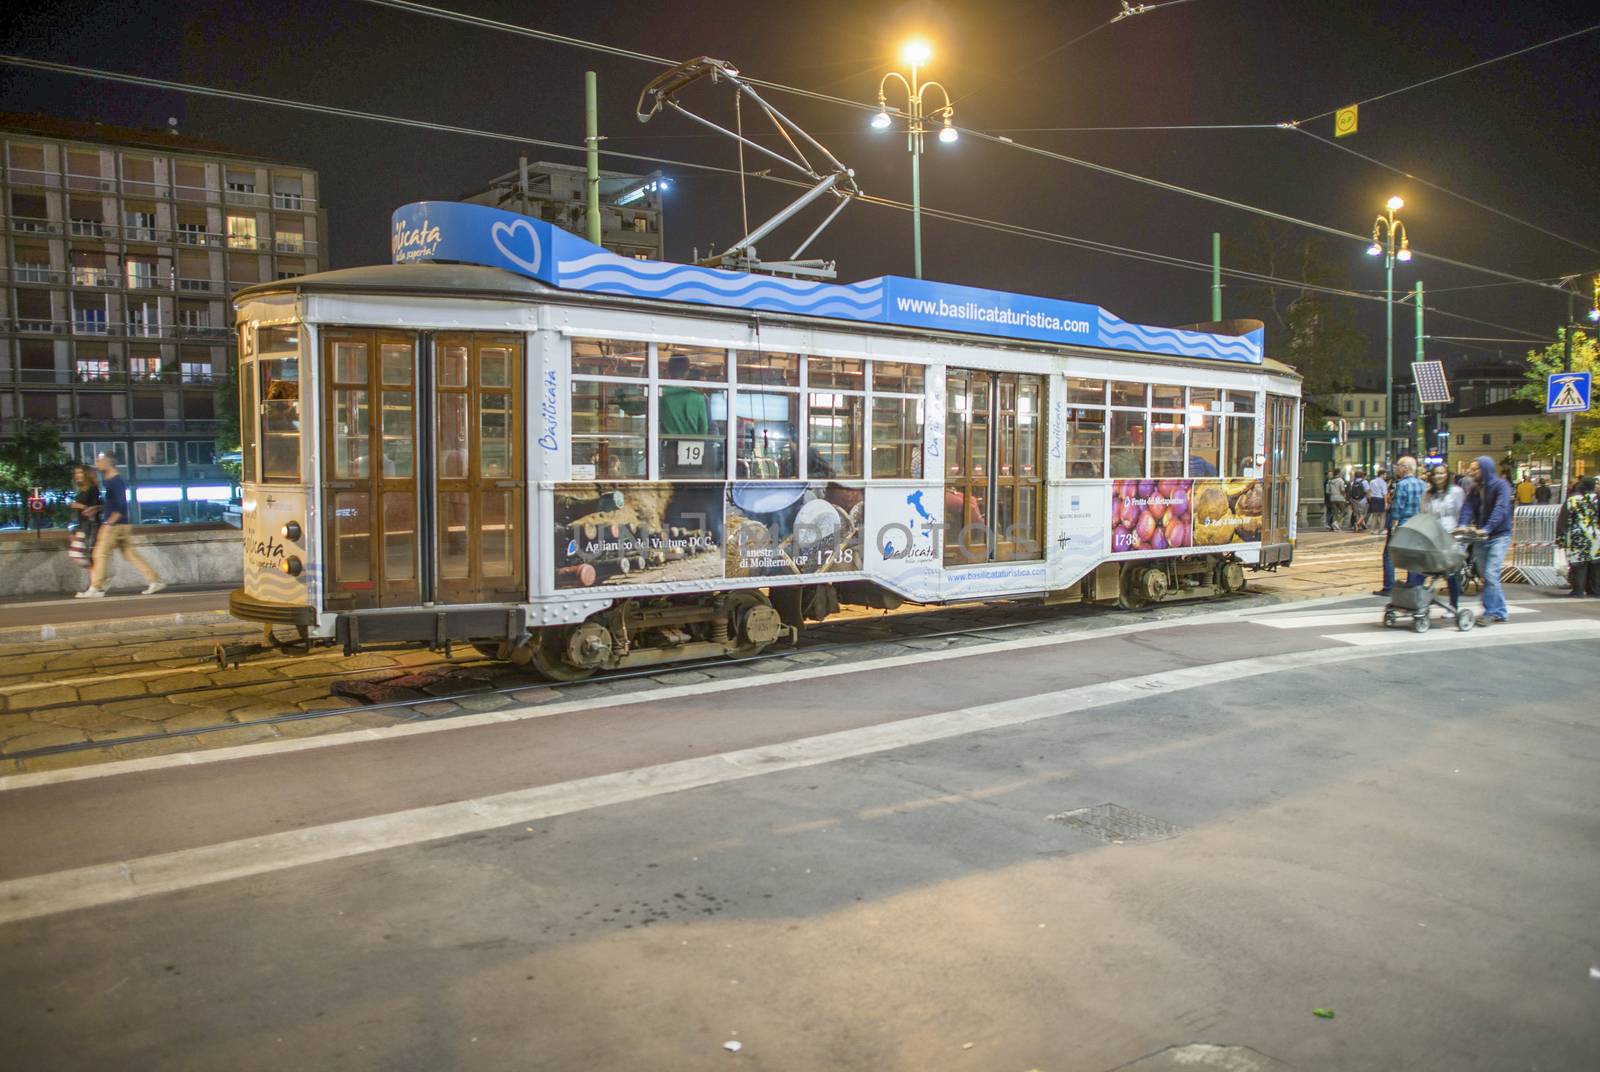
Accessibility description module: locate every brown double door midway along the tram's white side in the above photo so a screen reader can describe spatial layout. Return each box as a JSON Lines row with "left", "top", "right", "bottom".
{"left": 944, "top": 368, "right": 1045, "bottom": 566}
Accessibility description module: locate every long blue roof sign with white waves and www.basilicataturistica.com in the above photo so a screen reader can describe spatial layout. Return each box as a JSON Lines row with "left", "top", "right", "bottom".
{"left": 390, "top": 202, "right": 1262, "bottom": 365}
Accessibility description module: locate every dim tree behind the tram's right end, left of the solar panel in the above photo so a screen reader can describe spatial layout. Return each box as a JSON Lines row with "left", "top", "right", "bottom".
{"left": 1232, "top": 221, "right": 1376, "bottom": 395}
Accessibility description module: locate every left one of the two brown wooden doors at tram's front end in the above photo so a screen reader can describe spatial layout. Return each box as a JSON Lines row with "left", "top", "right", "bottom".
{"left": 322, "top": 330, "right": 419, "bottom": 610}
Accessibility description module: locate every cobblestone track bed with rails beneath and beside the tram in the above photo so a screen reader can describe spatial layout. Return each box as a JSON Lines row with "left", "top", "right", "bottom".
{"left": 0, "top": 533, "right": 1401, "bottom": 773}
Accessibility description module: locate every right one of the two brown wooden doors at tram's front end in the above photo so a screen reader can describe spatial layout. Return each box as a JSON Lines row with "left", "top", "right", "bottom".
{"left": 432, "top": 333, "right": 528, "bottom": 603}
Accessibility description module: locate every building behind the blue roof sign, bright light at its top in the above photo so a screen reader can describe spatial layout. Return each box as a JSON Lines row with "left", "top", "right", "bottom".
{"left": 458, "top": 157, "right": 670, "bottom": 261}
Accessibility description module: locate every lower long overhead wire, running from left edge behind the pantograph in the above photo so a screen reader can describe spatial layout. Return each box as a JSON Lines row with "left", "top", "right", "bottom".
{"left": 0, "top": 54, "right": 1561, "bottom": 344}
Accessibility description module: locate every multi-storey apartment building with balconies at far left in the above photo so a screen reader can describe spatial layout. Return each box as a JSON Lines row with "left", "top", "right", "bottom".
{"left": 0, "top": 114, "right": 328, "bottom": 522}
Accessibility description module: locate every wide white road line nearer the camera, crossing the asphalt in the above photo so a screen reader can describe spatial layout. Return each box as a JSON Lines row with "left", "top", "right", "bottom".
{"left": 0, "top": 621, "right": 1600, "bottom": 923}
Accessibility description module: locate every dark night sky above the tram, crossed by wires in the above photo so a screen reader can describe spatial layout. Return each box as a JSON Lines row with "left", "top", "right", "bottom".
{"left": 0, "top": 0, "right": 1600, "bottom": 374}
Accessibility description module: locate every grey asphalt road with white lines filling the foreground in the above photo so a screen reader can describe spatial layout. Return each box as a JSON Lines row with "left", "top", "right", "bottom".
{"left": 0, "top": 597, "right": 1600, "bottom": 1072}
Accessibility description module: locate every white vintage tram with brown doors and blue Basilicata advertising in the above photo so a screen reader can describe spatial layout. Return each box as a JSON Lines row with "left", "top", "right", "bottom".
{"left": 229, "top": 202, "right": 1299, "bottom": 680}
